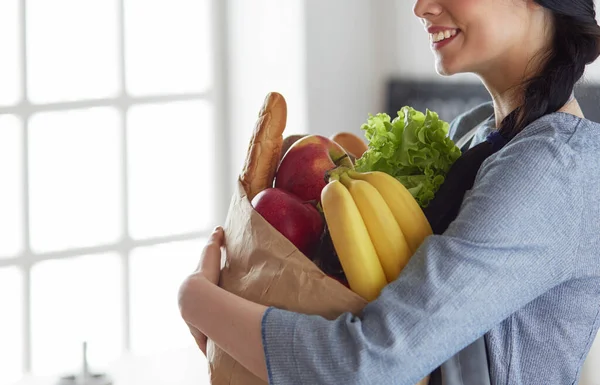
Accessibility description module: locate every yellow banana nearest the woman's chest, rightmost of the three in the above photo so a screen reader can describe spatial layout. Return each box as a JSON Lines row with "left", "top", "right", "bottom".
{"left": 347, "top": 170, "right": 433, "bottom": 253}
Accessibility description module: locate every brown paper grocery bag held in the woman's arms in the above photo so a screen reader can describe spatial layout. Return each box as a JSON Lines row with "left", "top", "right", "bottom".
{"left": 207, "top": 180, "right": 427, "bottom": 385}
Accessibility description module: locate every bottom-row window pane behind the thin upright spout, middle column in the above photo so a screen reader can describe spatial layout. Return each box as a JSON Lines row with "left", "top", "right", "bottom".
{"left": 31, "top": 254, "right": 123, "bottom": 375}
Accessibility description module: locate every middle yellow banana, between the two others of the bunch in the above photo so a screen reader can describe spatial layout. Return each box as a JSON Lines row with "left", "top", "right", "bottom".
{"left": 340, "top": 174, "right": 412, "bottom": 282}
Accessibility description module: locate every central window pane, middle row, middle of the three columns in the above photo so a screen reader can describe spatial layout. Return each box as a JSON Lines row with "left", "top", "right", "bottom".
{"left": 29, "top": 108, "right": 121, "bottom": 251}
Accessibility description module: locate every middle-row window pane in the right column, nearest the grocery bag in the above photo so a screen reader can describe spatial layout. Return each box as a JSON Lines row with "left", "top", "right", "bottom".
{"left": 128, "top": 101, "right": 215, "bottom": 238}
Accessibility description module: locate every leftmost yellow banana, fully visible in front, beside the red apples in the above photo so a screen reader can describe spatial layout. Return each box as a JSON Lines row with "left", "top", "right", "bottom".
{"left": 321, "top": 179, "right": 387, "bottom": 301}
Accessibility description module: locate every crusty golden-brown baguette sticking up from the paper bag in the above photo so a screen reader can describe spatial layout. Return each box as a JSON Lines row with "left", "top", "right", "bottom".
{"left": 240, "top": 92, "right": 287, "bottom": 201}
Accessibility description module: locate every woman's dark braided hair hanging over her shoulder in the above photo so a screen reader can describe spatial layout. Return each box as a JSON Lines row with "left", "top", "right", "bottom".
{"left": 499, "top": 0, "right": 600, "bottom": 140}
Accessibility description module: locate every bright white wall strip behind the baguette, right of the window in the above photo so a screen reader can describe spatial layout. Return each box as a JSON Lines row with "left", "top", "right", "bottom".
{"left": 227, "top": 0, "right": 308, "bottom": 188}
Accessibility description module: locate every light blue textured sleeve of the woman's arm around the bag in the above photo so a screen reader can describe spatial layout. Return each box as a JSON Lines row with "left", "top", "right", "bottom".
{"left": 262, "top": 130, "right": 582, "bottom": 385}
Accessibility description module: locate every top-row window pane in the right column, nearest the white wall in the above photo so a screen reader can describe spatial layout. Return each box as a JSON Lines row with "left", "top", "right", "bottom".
{"left": 125, "top": 0, "right": 213, "bottom": 95}
